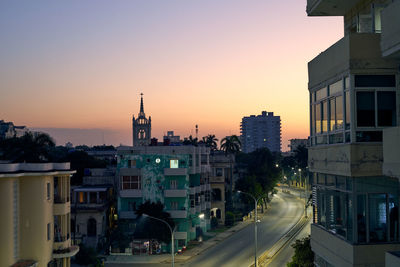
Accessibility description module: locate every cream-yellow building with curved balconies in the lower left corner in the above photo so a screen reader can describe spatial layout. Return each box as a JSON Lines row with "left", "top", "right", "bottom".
{"left": 0, "top": 163, "right": 79, "bottom": 267}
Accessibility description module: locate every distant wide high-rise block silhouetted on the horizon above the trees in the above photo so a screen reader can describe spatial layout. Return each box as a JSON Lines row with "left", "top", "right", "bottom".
{"left": 240, "top": 111, "right": 281, "bottom": 153}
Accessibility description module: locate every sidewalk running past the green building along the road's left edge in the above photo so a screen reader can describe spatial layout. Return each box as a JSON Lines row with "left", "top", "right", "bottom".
{"left": 106, "top": 215, "right": 256, "bottom": 263}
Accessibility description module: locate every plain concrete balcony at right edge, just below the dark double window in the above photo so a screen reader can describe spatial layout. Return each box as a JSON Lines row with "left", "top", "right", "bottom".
{"left": 383, "top": 127, "right": 400, "bottom": 178}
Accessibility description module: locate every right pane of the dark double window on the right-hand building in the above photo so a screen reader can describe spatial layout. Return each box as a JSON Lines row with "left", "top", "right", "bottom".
{"left": 378, "top": 92, "right": 396, "bottom": 126}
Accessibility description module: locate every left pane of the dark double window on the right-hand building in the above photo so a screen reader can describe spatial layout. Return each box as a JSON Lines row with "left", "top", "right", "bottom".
{"left": 357, "top": 92, "right": 375, "bottom": 127}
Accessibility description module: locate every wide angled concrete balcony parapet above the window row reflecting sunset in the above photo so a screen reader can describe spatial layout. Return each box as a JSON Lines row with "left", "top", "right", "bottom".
{"left": 308, "top": 33, "right": 398, "bottom": 89}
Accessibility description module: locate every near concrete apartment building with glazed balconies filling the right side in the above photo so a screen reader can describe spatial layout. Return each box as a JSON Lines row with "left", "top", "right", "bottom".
{"left": 307, "top": 0, "right": 400, "bottom": 267}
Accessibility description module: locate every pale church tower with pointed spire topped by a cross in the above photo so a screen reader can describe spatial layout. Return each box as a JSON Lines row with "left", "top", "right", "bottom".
{"left": 132, "top": 94, "right": 151, "bottom": 146}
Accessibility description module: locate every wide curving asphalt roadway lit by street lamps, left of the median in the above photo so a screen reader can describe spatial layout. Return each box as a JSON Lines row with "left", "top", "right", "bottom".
{"left": 179, "top": 193, "right": 304, "bottom": 267}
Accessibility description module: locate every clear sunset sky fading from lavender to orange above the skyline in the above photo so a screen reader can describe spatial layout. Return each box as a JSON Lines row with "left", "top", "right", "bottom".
{"left": 0, "top": 0, "right": 343, "bottom": 150}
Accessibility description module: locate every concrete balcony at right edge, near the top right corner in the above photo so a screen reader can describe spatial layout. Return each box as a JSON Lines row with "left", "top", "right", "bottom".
{"left": 381, "top": 1, "right": 400, "bottom": 59}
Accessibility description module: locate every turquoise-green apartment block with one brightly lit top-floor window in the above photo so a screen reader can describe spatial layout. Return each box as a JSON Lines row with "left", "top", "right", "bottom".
{"left": 117, "top": 146, "right": 211, "bottom": 252}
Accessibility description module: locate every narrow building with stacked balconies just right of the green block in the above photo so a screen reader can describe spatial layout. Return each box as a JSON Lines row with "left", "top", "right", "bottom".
{"left": 210, "top": 151, "right": 235, "bottom": 224}
